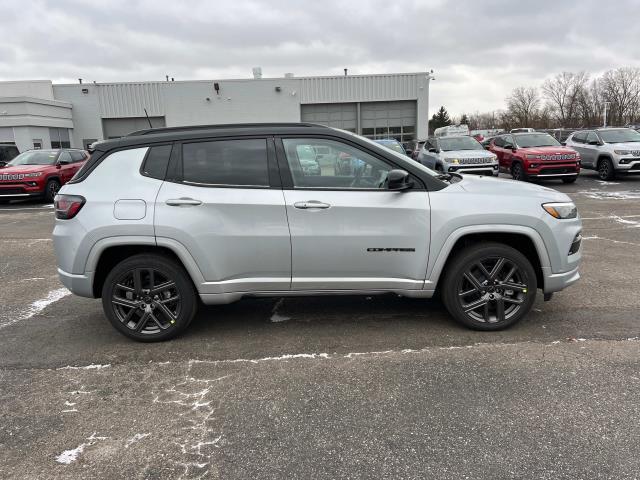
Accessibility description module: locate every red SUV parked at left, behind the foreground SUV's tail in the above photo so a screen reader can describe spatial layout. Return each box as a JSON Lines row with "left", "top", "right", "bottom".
{"left": 0, "top": 148, "right": 89, "bottom": 203}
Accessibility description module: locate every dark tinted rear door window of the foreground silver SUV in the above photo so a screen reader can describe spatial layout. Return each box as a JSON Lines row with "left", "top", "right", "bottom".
{"left": 182, "top": 139, "right": 269, "bottom": 186}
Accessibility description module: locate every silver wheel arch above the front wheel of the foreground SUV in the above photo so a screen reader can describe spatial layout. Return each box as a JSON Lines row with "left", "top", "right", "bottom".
{"left": 425, "top": 225, "right": 551, "bottom": 290}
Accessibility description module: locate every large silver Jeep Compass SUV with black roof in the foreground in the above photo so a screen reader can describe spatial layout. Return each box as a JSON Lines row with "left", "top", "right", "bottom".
{"left": 53, "top": 123, "right": 582, "bottom": 341}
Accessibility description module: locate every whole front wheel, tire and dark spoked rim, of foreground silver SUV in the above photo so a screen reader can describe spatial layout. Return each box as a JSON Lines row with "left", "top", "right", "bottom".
{"left": 441, "top": 243, "right": 538, "bottom": 331}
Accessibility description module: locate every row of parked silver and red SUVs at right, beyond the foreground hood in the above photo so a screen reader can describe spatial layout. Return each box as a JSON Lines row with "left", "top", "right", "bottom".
{"left": 398, "top": 125, "right": 640, "bottom": 183}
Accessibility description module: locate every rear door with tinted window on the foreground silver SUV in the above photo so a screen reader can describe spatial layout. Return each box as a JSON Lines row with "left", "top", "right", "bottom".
{"left": 155, "top": 138, "right": 291, "bottom": 294}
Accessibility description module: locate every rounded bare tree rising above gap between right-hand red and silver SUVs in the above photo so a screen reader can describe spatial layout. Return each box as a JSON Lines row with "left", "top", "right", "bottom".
{"left": 542, "top": 72, "right": 589, "bottom": 127}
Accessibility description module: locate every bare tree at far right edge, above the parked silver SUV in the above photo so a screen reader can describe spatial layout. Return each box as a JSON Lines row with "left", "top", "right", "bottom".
{"left": 601, "top": 67, "right": 640, "bottom": 125}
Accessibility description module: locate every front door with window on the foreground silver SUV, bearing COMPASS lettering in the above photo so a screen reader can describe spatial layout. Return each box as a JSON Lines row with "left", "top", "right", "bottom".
{"left": 277, "top": 138, "right": 430, "bottom": 290}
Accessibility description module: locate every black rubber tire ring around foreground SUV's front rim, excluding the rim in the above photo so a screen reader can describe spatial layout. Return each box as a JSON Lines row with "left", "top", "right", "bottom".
{"left": 442, "top": 243, "right": 538, "bottom": 331}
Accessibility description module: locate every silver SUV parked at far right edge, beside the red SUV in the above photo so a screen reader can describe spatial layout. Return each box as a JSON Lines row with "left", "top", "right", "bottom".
{"left": 567, "top": 128, "right": 640, "bottom": 180}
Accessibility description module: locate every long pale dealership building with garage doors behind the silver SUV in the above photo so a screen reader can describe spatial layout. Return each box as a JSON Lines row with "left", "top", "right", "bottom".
{"left": 0, "top": 72, "right": 430, "bottom": 151}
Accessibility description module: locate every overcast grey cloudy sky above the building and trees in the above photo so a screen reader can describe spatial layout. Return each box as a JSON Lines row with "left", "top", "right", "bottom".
{"left": 0, "top": 0, "right": 640, "bottom": 115}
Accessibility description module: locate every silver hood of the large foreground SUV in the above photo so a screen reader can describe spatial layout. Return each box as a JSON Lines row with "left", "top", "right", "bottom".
{"left": 454, "top": 175, "right": 572, "bottom": 202}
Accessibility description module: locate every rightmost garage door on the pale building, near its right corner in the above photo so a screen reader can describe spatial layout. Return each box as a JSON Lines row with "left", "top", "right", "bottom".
{"left": 360, "top": 101, "right": 417, "bottom": 142}
